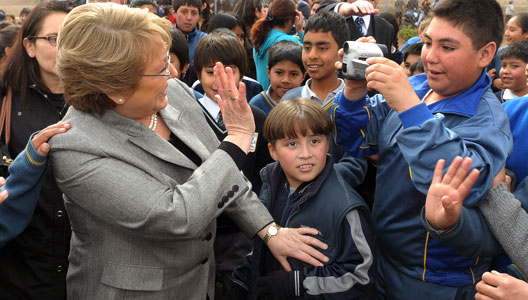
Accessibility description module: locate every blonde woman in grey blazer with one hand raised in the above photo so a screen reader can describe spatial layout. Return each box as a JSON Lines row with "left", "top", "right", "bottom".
{"left": 50, "top": 3, "right": 325, "bottom": 299}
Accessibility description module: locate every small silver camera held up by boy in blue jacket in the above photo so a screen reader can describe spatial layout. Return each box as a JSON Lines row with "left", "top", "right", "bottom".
{"left": 341, "top": 41, "right": 389, "bottom": 80}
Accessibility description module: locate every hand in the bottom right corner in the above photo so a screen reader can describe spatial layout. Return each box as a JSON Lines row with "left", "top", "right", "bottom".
{"left": 475, "top": 271, "right": 528, "bottom": 300}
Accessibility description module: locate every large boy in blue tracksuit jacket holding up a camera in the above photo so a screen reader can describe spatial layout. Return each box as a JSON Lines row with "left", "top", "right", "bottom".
{"left": 335, "top": 0, "right": 512, "bottom": 299}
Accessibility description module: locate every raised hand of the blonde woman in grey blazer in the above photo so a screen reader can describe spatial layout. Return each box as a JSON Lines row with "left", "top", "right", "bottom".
{"left": 214, "top": 62, "right": 255, "bottom": 153}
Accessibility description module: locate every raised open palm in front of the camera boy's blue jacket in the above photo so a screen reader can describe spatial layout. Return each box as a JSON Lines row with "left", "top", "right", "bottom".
{"left": 425, "top": 156, "right": 479, "bottom": 229}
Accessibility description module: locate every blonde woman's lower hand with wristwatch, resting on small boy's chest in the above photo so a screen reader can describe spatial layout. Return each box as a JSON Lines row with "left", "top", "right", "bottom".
{"left": 259, "top": 225, "right": 328, "bottom": 272}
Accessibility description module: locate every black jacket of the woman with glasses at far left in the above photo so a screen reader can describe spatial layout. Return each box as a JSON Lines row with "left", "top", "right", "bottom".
{"left": 0, "top": 85, "right": 71, "bottom": 300}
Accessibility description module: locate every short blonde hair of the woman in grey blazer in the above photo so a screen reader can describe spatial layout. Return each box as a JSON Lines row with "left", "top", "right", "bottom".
{"left": 57, "top": 3, "right": 172, "bottom": 113}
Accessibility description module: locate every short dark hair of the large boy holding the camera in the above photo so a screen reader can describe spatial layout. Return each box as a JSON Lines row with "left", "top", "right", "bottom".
{"left": 430, "top": 0, "right": 504, "bottom": 50}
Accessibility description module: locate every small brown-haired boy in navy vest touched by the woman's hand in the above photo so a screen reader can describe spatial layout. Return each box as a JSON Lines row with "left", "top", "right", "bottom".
{"left": 230, "top": 98, "right": 374, "bottom": 300}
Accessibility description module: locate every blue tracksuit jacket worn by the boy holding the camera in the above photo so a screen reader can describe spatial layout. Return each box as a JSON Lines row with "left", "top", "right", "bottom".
{"left": 335, "top": 72, "right": 512, "bottom": 287}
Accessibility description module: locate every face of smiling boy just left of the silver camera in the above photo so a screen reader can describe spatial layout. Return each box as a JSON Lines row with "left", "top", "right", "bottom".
{"left": 302, "top": 31, "right": 339, "bottom": 80}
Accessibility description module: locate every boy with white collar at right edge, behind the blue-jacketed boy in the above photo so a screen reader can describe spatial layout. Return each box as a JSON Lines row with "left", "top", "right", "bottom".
{"left": 495, "top": 40, "right": 528, "bottom": 103}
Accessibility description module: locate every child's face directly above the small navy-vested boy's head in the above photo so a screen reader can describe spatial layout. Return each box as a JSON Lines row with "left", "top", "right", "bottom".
{"left": 268, "top": 60, "right": 304, "bottom": 100}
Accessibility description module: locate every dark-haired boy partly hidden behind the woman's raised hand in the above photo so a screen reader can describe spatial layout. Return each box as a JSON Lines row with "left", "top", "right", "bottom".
{"left": 194, "top": 29, "right": 272, "bottom": 291}
